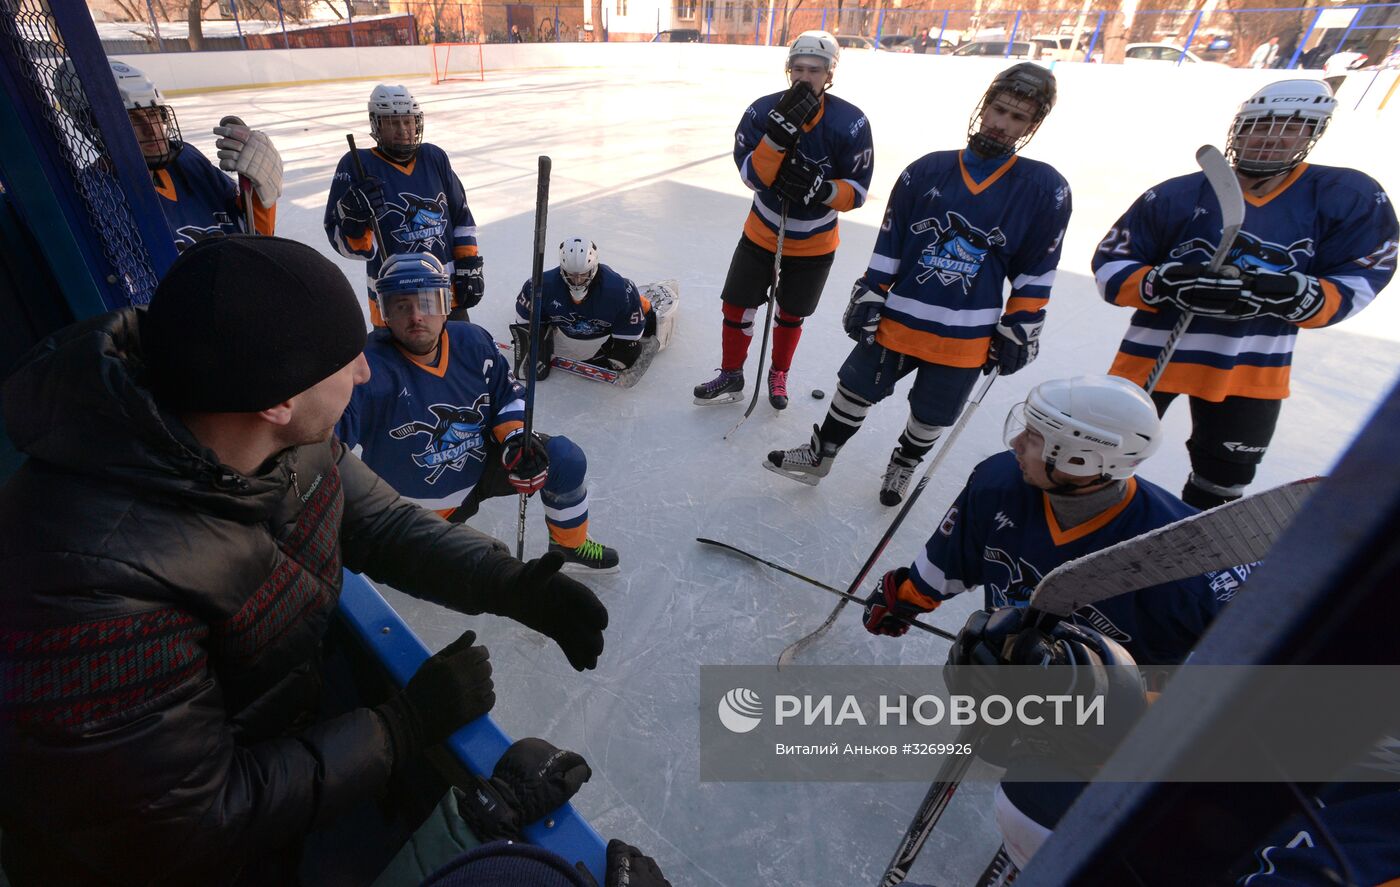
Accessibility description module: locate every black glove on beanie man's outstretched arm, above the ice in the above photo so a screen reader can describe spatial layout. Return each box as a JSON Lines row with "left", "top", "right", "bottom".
{"left": 475, "top": 551, "right": 608, "bottom": 672}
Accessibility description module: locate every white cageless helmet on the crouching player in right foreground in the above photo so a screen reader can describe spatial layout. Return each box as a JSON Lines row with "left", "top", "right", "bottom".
{"left": 1002, "top": 376, "right": 1162, "bottom": 480}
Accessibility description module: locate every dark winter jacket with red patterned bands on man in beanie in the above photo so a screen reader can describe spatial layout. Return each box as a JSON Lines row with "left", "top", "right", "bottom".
{"left": 0, "top": 309, "right": 515, "bottom": 884}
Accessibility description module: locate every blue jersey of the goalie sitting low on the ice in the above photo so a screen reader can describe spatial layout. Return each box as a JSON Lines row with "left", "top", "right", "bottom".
{"left": 515, "top": 264, "right": 651, "bottom": 341}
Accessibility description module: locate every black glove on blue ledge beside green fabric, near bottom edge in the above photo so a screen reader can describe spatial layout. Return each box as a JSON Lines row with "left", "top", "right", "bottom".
{"left": 458, "top": 737, "right": 594, "bottom": 841}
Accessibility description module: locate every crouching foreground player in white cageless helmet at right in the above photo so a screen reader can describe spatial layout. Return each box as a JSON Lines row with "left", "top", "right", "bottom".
{"left": 865, "top": 376, "right": 1249, "bottom": 665}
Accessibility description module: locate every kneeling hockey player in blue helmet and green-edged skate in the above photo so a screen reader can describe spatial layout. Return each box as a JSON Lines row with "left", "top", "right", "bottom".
{"left": 336, "top": 252, "right": 617, "bottom": 572}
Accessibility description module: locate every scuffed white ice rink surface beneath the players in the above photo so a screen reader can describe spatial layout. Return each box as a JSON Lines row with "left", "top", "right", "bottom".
{"left": 174, "top": 53, "right": 1400, "bottom": 887}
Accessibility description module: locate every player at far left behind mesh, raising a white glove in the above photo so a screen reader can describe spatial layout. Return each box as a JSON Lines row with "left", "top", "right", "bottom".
{"left": 66, "top": 60, "right": 281, "bottom": 250}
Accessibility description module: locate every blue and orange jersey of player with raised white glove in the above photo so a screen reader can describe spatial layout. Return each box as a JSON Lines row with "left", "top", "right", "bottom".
{"left": 151, "top": 144, "right": 277, "bottom": 250}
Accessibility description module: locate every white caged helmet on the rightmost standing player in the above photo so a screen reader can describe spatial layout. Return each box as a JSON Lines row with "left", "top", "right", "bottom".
{"left": 1225, "top": 80, "right": 1337, "bottom": 179}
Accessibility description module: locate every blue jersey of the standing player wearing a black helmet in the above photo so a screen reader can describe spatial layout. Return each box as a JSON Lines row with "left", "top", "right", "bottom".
{"left": 865, "top": 150, "right": 1071, "bottom": 367}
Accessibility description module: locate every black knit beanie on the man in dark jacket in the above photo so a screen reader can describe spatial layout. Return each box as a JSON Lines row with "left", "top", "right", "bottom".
{"left": 140, "top": 235, "right": 365, "bottom": 413}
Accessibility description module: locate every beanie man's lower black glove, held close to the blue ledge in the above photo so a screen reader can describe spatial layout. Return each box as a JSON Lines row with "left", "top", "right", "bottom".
{"left": 374, "top": 631, "right": 496, "bottom": 767}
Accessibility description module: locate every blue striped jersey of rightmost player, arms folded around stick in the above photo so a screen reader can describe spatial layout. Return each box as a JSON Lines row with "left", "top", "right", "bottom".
{"left": 1093, "top": 164, "right": 1397, "bottom": 402}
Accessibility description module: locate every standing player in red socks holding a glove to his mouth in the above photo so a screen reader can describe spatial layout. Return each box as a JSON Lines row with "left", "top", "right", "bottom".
{"left": 694, "top": 31, "right": 875, "bottom": 410}
